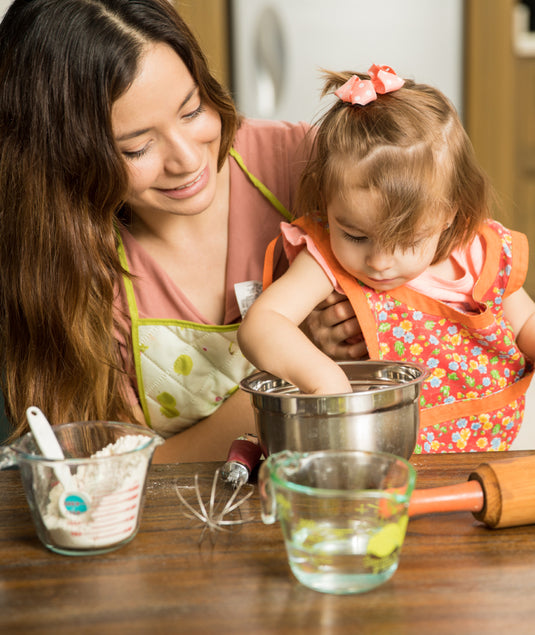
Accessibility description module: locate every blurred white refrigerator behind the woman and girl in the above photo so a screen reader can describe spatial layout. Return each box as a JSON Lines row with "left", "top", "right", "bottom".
{"left": 230, "top": 0, "right": 463, "bottom": 121}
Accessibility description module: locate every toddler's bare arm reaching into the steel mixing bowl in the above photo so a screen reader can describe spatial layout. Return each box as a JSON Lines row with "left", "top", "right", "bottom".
{"left": 238, "top": 250, "right": 351, "bottom": 394}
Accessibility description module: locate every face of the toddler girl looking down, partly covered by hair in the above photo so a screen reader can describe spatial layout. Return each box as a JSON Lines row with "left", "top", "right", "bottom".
{"left": 327, "top": 188, "right": 445, "bottom": 291}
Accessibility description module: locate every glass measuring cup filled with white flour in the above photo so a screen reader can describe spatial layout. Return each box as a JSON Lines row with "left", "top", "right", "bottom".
{"left": 0, "top": 421, "right": 163, "bottom": 555}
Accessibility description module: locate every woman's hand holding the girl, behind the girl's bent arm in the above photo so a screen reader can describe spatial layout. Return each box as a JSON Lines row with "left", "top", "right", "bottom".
{"left": 301, "top": 291, "right": 368, "bottom": 361}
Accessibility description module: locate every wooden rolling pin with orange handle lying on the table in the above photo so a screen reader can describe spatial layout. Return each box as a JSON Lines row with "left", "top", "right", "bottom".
{"left": 409, "top": 456, "right": 535, "bottom": 529}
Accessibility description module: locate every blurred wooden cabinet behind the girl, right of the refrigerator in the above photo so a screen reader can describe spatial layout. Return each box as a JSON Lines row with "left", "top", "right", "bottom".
{"left": 465, "top": 0, "right": 535, "bottom": 299}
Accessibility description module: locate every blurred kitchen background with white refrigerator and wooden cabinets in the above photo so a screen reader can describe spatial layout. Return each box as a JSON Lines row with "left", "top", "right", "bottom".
{"left": 0, "top": 0, "right": 535, "bottom": 448}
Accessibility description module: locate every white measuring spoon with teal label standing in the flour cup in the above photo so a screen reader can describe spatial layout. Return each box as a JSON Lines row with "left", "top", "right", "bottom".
{"left": 26, "top": 406, "right": 90, "bottom": 515}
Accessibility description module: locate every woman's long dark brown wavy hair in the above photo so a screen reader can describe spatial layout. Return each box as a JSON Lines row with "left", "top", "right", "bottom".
{"left": 0, "top": 0, "right": 239, "bottom": 437}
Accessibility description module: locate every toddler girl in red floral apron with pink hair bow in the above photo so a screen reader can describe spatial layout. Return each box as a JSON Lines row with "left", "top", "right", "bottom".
{"left": 238, "top": 65, "right": 535, "bottom": 452}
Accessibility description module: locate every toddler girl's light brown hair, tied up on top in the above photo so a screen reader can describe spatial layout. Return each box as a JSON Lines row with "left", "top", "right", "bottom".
{"left": 297, "top": 71, "right": 489, "bottom": 262}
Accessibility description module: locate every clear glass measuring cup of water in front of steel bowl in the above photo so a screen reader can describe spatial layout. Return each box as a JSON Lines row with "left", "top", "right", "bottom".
{"left": 258, "top": 450, "right": 416, "bottom": 594}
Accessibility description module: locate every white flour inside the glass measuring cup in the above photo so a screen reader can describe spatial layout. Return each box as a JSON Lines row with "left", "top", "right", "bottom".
{"left": 39, "top": 434, "right": 148, "bottom": 549}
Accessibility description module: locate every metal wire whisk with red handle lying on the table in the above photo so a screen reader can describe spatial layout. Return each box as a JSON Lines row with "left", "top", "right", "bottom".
{"left": 175, "top": 434, "right": 262, "bottom": 545}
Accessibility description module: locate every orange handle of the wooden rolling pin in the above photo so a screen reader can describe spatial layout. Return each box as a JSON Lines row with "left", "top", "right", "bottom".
{"left": 409, "top": 480, "right": 485, "bottom": 516}
